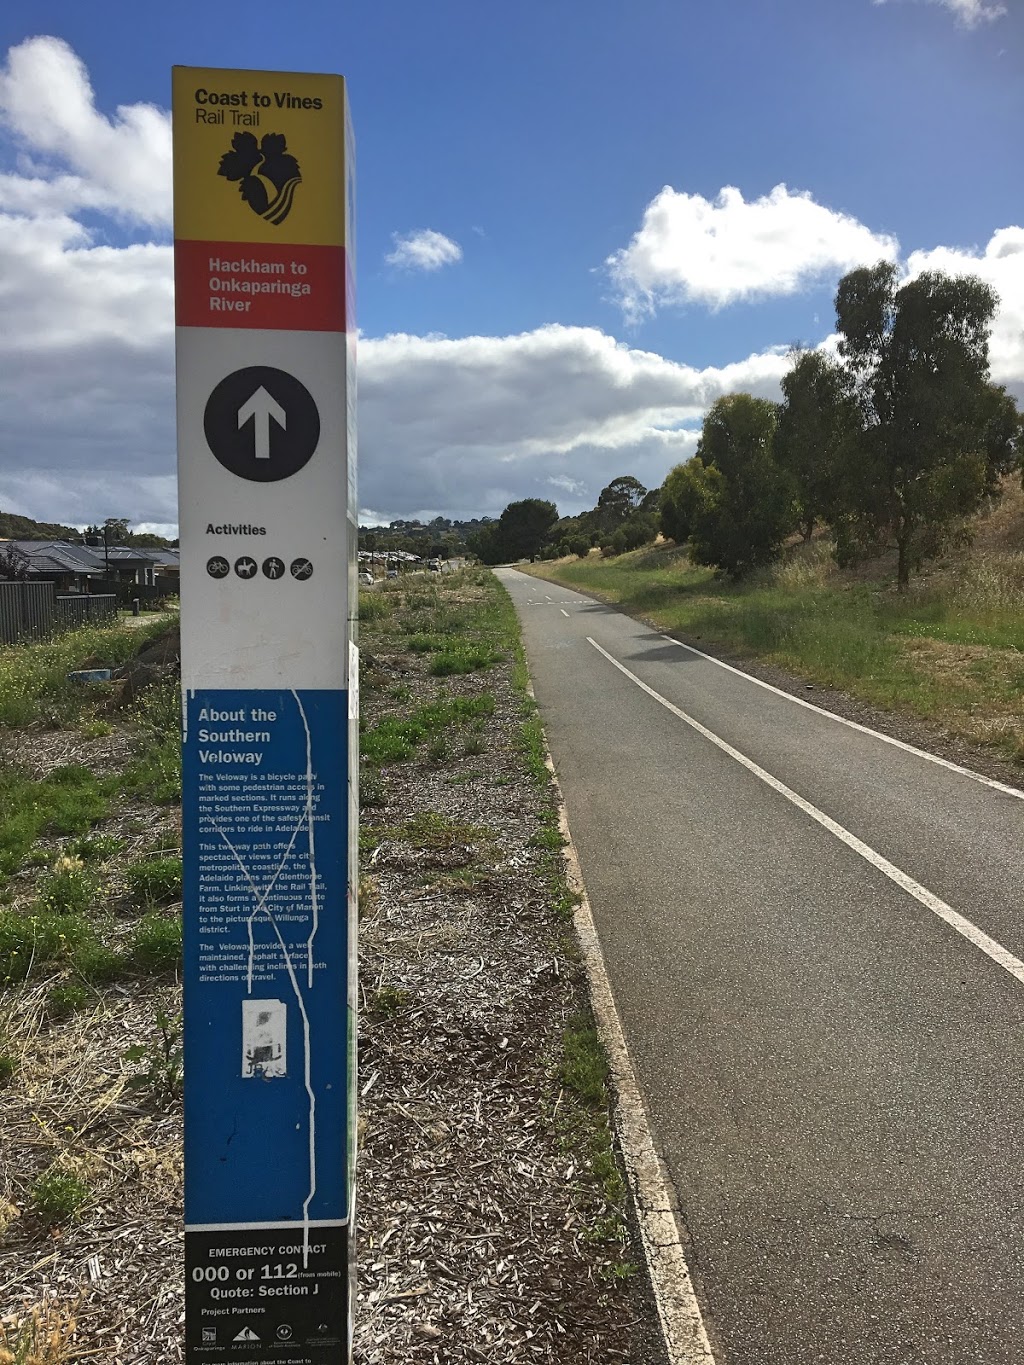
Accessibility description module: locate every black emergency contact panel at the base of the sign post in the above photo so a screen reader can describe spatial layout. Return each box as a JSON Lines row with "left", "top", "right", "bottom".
{"left": 184, "top": 1224, "right": 350, "bottom": 1365}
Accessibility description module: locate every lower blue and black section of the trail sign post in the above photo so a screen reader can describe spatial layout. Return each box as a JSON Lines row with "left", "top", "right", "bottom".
{"left": 183, "top": 689, "right": 354, "bottom": 1365}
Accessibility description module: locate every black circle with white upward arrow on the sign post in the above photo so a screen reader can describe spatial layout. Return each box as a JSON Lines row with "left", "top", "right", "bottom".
{"left": 202, "top": 364, "right": 319, "bottom": 483}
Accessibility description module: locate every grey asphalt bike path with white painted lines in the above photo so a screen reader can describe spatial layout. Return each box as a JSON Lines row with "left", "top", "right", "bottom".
{"left": 498, "top": 569, "right": 1024, "bottom": 1365}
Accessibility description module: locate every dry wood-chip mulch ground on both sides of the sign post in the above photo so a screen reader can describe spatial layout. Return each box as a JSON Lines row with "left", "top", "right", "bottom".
{"left": 0, "top": 603, "right": 661, "bottom": 1365}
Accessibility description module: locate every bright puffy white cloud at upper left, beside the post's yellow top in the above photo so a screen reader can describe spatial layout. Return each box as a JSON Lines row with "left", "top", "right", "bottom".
{"left": 0, "top": 37, "right": 171, "bottom": 227}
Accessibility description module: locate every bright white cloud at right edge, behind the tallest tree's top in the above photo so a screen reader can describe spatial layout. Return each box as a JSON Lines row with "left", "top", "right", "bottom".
{"left": 907, "top": 227, "right": 1024, "bottom": 403}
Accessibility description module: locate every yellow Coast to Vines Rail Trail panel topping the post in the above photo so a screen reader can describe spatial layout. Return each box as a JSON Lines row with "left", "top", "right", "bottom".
{"left": 172, "top": 67, "right": 351, "bottom": 247}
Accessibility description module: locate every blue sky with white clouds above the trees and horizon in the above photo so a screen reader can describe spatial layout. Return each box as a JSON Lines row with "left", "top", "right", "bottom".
{"left": 0, "top": 0, "right": 1024, "bottom": 535}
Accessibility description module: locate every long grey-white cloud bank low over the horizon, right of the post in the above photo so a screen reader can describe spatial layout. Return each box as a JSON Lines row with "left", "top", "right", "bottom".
{"left": 359, "top": 325, "right": 788, "bottom": 516}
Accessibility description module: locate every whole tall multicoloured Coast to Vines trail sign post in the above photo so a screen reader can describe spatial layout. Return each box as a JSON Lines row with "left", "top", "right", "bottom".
{"left": 173, "top": 67, "right": 359, "bottom": 1365}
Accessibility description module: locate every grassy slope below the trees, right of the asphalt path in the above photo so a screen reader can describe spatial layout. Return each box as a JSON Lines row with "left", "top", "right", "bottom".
{"left": 530, "top": 480, "right": 1024, "bottom": 766}
